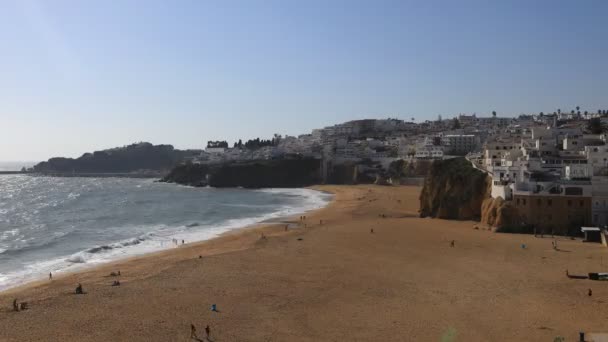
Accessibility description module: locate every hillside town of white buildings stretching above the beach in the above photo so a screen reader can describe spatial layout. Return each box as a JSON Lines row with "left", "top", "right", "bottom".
{"left": 191, "top": 107, "right": 608, "bottom": 231}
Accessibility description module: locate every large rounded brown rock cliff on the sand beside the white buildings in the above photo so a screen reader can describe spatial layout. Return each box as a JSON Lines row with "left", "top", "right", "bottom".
{"left": 420, "top": 158, "right": 492, "bottom": 220}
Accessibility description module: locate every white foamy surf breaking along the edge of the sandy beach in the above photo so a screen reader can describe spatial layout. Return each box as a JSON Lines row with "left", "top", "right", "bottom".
{"left": 0, "top": 184, "right": 331, "bottom": 291}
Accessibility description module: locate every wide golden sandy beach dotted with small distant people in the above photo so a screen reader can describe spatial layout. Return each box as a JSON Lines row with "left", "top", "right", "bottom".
{"left": 0, "top": 186, "right": 608, "bottom": 341}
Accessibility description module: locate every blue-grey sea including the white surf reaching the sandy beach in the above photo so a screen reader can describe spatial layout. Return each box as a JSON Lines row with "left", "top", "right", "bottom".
{"left": 0, "top": 175, "right": 331, "bottom": 291}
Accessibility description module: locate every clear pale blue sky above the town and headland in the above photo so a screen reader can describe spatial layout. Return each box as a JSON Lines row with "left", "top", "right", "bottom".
{"left": 0, "top": 0, "right": 608, "bottom": 160}
